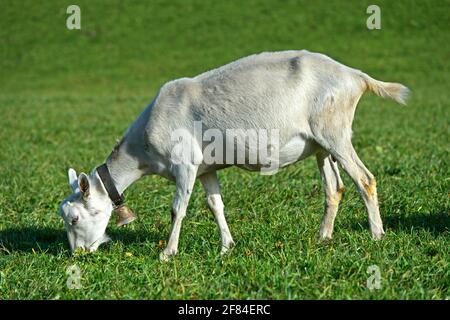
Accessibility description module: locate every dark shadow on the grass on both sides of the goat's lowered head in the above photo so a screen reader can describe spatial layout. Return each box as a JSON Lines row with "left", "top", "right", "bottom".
{"left": 0, "top": 227, "right": 162, "bottom": 255}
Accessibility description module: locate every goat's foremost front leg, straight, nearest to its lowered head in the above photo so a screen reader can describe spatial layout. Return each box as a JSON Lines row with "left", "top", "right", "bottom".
{"left": 160, "top": 164, "right": 197, "bottom": 261}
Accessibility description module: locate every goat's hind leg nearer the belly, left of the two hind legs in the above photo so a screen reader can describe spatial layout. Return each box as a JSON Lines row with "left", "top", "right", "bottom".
{"left": 316, "top": 151, "right": 344, "bottom": 240}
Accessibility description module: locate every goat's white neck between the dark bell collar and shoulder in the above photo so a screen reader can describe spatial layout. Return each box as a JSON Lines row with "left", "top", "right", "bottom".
{"left": 106, "top": 148, "right": 143, "bottom": 194}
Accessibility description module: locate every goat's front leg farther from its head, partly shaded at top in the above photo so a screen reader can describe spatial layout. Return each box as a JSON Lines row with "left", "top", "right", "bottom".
{"left": 200, "top": 171, "right": 234, "bottom": 255}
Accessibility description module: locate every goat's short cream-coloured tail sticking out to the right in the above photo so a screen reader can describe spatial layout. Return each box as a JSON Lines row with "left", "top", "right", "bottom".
{"left": 360, "top": 72, "right": 410, "bottom": 105}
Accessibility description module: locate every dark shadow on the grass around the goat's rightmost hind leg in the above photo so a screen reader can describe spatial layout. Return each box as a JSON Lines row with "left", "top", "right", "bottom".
{"left": 349, "top": 208, "right": 450, "bottom": 236}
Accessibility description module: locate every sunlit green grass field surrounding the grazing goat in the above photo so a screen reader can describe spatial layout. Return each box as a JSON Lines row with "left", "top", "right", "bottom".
{"left": 0, "top": 0, "right": 450, "bottom": 299}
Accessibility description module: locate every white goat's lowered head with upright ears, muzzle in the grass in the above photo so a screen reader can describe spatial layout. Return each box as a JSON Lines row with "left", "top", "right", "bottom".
{"left": 60, "top": 168, "right": 113, "bottom": 252}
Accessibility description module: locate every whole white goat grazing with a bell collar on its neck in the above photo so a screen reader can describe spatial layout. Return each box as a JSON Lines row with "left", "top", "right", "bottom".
{"left": 61, "top": 50, "right": 408, "bottom": 260}
